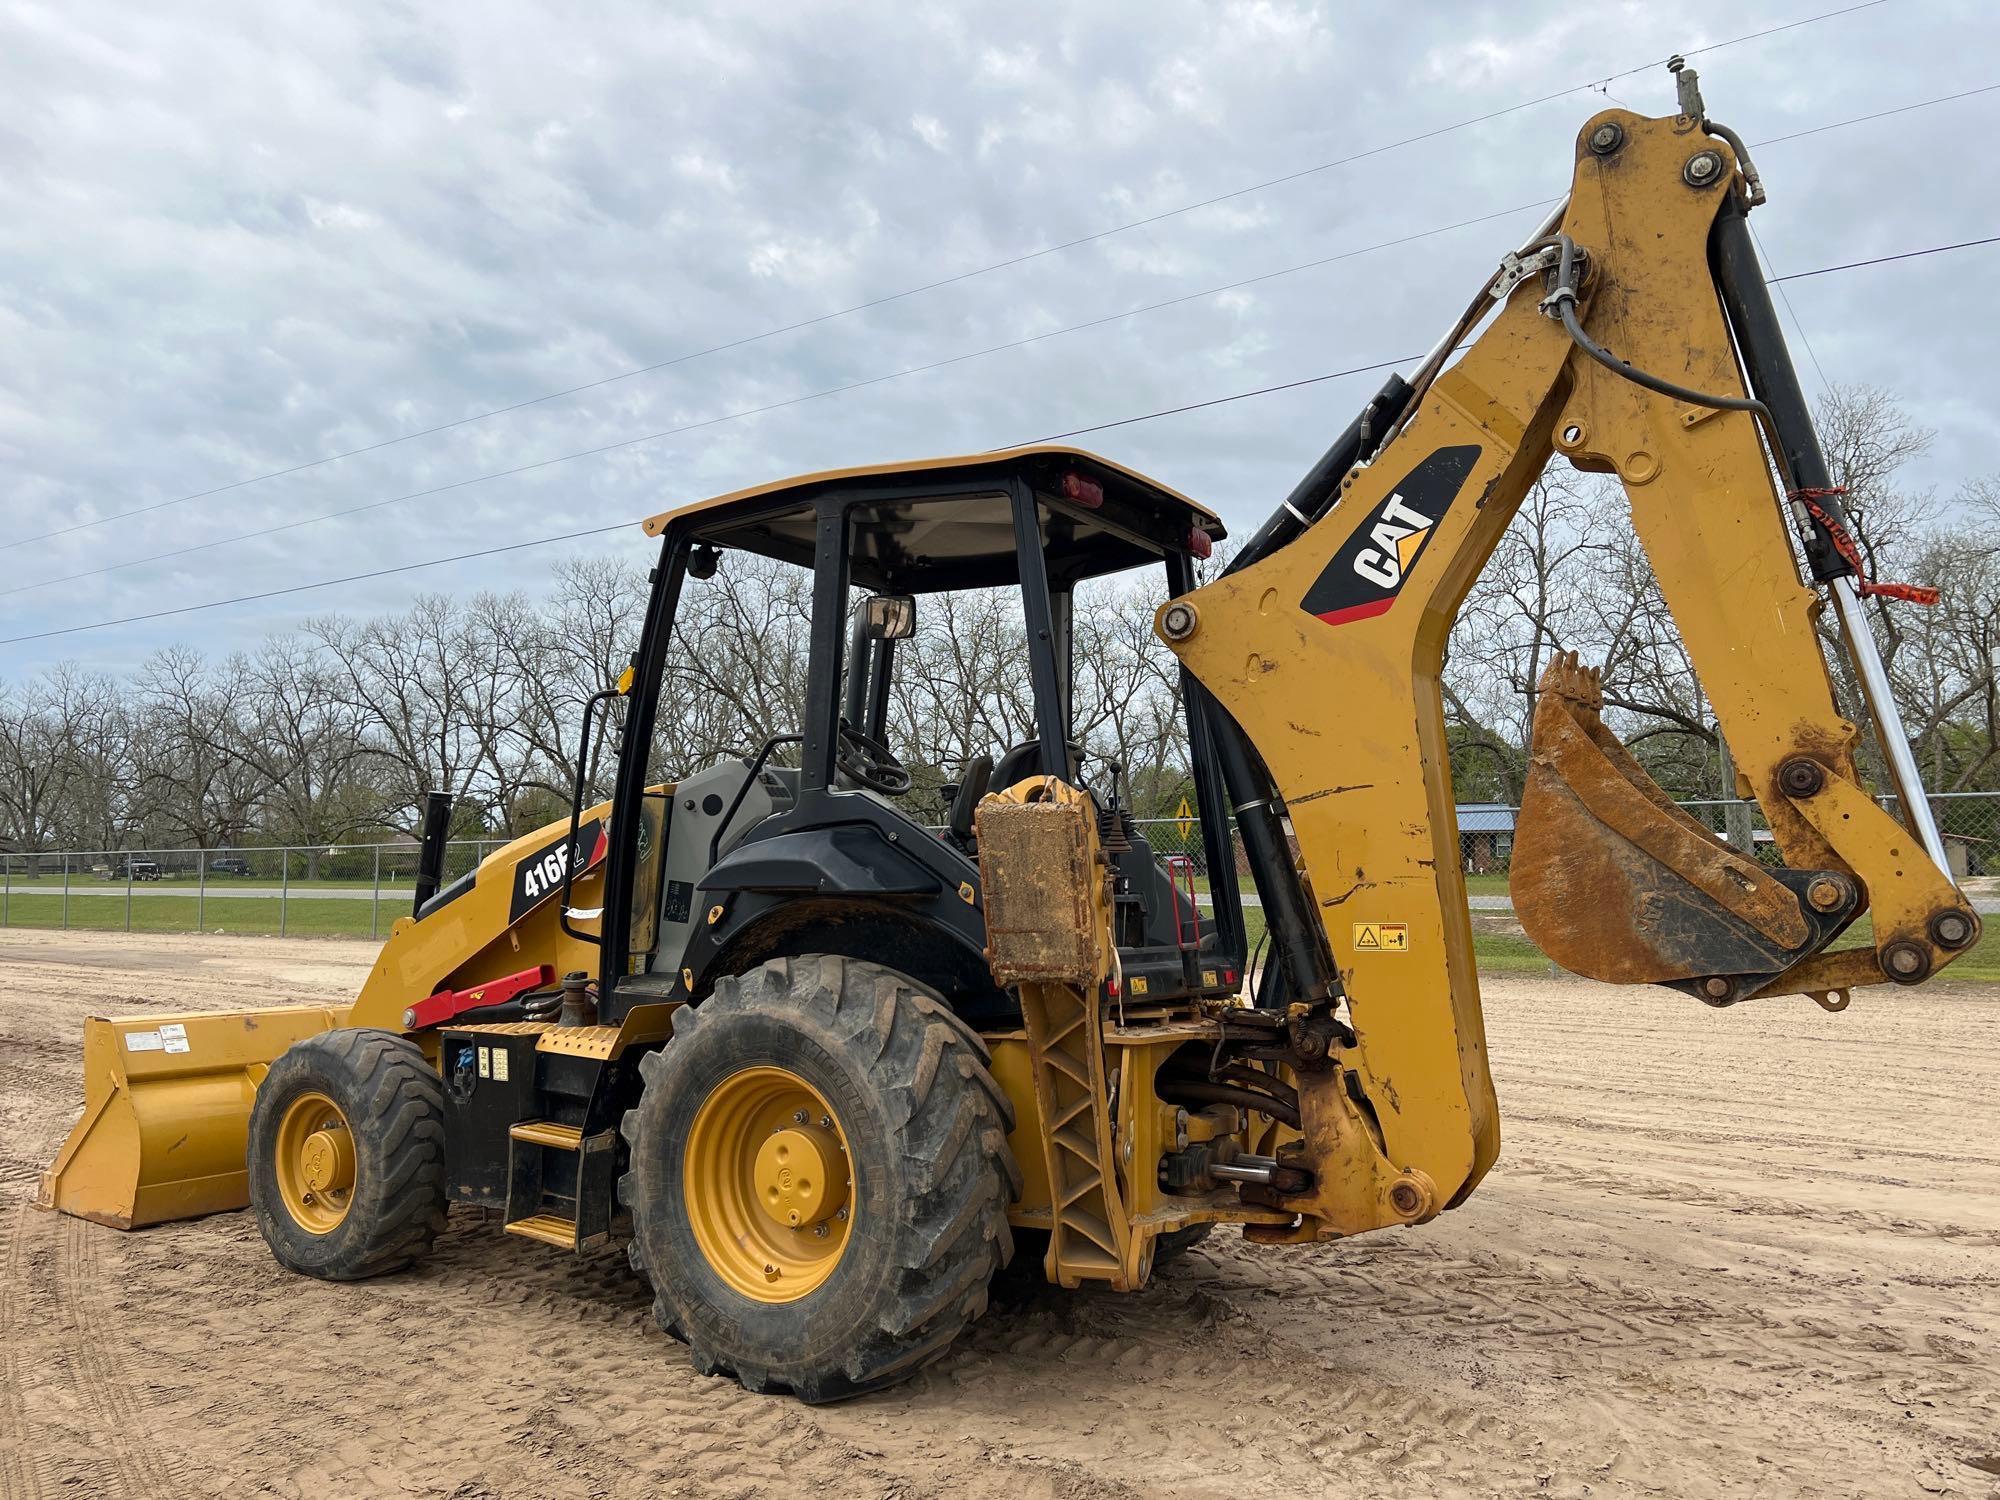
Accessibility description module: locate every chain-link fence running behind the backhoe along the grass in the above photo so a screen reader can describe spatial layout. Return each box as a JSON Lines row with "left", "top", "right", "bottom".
{"left": 0, "top": 792, "right": 2000, "bottom": 938}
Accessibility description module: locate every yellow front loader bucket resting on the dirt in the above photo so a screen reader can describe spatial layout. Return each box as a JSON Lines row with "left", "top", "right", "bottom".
{"left": 36, "top": 1006, "right": 346, "bottom": 1230}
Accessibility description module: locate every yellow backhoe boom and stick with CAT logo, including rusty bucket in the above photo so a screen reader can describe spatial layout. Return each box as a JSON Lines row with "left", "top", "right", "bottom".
{"left": 1156, "top": 97, "right": 1978, "bottom": 1238}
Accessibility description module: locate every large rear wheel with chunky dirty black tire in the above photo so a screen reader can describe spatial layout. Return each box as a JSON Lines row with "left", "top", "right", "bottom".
{"left": 618, "top": 954, "right": 1020, "bottom": 1402}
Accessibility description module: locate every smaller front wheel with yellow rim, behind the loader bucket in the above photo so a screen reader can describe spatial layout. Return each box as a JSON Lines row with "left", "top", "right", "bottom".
{"left": 248, "top": 1028, "right": 446, "bottom": 1282}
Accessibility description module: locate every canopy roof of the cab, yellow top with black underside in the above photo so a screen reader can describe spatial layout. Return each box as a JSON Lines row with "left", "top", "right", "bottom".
{"left": 646, "top": 448, "right": 1224, "bottom": 594}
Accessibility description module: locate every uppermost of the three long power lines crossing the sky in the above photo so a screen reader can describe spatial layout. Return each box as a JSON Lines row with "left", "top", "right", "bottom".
{"left": 0, "top": 0, "right": 1888, "bottom": 552}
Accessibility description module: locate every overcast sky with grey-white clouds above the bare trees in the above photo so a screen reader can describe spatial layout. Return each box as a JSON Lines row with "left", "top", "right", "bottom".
{"left": 0, "top": 0, "right": 2000, "bottom": 678}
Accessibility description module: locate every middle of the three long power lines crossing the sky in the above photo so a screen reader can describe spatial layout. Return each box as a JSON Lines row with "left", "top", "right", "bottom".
{"left": 11, "top": 84, "right": 2000, "bottom": 598}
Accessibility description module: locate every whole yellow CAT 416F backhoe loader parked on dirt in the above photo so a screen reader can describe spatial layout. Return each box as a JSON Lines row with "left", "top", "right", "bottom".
{"left": 42, "top": 72, "right": 1980, "bottom": 1400}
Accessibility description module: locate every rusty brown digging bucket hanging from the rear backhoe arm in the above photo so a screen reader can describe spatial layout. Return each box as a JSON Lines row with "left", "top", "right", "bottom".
{"left": 1510, "top": 652, "right": 1832, "bottom": 1004}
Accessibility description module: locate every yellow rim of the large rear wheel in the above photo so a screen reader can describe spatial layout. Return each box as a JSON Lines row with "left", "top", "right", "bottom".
{"left": 682, "top": 1068, "right": 854, "bottom": 1302}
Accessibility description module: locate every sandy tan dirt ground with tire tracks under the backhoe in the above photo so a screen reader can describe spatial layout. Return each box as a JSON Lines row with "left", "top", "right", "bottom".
{"left": 0, "top": 932, "right": 2000, "bottom": 1500}
